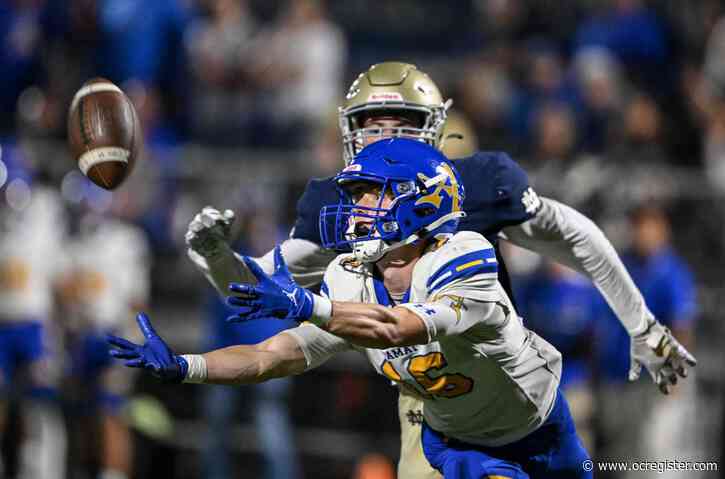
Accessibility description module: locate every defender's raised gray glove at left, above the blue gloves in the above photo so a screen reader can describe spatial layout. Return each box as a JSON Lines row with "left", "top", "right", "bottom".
{"left": 184, "top": 206, "right": 234, "bottom": 258}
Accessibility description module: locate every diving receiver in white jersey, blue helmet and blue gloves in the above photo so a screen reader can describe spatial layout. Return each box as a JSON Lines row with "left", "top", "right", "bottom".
{"left": 110, "top": 139, "right": 652, "bottom": 478}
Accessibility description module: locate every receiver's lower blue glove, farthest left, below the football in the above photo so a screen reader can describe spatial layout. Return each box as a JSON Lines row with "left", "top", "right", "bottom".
{"left": 107, "top": 313, "right": 189, "bottom": 383}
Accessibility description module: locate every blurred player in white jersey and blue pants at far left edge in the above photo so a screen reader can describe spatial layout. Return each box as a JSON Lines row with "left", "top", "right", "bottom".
{"left": 0, "top": 143, "right": 67, "bottom": 479}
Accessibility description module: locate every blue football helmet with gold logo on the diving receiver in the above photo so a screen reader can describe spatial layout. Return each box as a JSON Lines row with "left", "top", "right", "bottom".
{"left": 320, "top": 138, "right": 465, "bottom": 263}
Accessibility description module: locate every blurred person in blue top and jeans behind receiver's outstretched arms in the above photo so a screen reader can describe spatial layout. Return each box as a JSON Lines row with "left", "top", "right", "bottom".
{"left": 202, "top": 206, "right": 302, "bottom": 479}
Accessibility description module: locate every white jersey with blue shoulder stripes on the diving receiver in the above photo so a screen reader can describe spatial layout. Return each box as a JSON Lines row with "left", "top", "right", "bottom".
{"left": 287, "top": 232, "right": 561, "bottom": 446}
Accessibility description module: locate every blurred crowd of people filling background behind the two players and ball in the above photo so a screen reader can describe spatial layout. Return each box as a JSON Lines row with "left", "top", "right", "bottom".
{"left": 0, "top": 0, "right": 725, "bottom": 479}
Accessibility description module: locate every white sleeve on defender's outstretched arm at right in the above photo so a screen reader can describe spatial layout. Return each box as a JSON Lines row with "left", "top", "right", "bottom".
{"left": 502, "top": 198, "right": 654, "bottom": 336}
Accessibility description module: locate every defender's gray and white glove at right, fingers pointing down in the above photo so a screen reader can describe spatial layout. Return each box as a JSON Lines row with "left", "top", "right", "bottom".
{"left": 629, "top": 321, "right": 697, "bottom": 394}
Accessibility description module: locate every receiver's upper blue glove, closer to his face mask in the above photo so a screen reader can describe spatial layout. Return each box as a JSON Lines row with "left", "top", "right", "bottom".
{"left": 227, "top": 246, "right": 314, "bottom": 322}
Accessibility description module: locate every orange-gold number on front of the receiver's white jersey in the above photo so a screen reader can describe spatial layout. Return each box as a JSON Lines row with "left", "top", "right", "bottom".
{"left": 382, "top": 352, "right": 473, "bottom": 398}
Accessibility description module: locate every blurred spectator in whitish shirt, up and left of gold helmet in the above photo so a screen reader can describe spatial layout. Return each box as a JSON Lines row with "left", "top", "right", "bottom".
{"left": 254, "top": 0, "right": 347, "bottom": 145}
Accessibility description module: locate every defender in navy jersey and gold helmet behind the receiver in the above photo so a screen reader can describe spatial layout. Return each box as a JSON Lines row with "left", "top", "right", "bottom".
{"left": 182, "top": 62, "right": 689, "bottom": 478}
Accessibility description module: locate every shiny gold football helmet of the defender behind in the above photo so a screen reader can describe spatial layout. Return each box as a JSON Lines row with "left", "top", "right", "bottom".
{"left": 338, "top": 62, "right": 453, "bottom": 165}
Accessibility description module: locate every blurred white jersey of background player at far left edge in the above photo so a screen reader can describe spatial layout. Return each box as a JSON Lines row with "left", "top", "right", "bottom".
{"left": 0, "top": 187, "right": 66, "bottom": 322}
